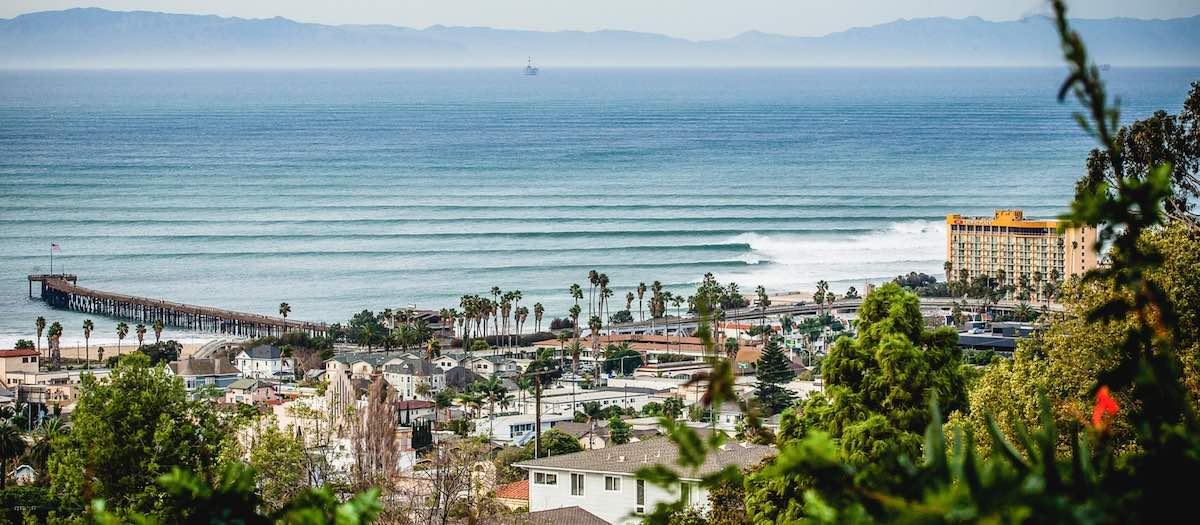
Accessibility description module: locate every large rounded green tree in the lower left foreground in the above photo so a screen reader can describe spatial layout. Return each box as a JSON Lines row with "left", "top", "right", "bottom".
{"left": 49, "top": 354, "right": 224, "bottom": 514}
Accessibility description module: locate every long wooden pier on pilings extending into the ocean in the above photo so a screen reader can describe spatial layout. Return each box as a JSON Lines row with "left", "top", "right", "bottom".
{"left": 29, "top": 273, "right": 329, "bottom": 337}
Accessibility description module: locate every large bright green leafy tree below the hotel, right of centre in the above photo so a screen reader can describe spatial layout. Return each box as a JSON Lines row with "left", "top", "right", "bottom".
{"left": 750, "top": 283, "right": 966, "bottom": 508}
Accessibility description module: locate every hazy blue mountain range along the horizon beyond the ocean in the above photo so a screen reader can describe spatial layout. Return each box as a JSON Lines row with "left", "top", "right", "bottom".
{"left": 0, "top": 8, "right": 1200, "bottom": 68}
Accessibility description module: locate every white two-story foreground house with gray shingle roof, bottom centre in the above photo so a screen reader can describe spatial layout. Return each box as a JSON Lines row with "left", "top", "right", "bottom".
{"left": 515, "top": 439, "right": 775, "bottom": 524}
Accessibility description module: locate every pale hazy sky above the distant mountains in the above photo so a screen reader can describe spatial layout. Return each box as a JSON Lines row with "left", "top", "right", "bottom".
{"left": 0, "top": 0, "right": 1200, "bottom": 38}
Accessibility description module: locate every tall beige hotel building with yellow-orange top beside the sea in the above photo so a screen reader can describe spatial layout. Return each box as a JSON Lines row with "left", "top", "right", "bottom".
{"left": 946, "top": 210, "right": 1097, "bottom": 292}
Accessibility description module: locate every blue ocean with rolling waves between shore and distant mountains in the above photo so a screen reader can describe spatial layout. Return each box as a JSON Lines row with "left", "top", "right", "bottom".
{"left": 0, "top": 68, "right": 1200, "bottom": 346}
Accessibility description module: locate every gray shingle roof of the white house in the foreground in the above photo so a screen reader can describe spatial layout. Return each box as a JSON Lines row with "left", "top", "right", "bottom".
{"left": 515, "top": 439, "right": 775, "bottom": 479}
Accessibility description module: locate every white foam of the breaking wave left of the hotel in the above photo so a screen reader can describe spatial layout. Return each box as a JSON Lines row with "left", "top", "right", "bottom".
{"left": 719, "top": 221, "right": 946, "bottom": 291}
